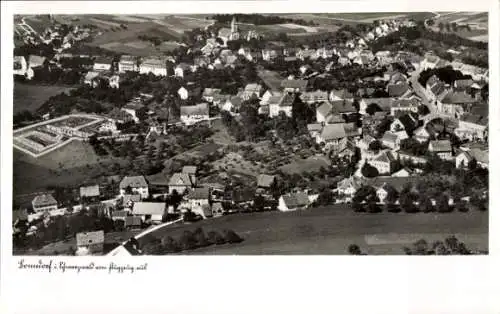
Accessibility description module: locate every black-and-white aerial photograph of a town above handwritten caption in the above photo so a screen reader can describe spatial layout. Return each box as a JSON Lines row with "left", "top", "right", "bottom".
{"left": 12, "top": 12, "right": 489, "bottom": 256}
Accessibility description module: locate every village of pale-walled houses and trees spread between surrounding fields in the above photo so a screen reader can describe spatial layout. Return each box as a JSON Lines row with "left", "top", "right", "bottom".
{"left": 13, "top": 13, "right": 489, "bottom": 256}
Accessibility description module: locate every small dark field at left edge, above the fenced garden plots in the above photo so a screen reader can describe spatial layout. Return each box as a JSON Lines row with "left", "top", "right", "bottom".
{"left": 14, "top": 82, "right": 72, "bottom": 114}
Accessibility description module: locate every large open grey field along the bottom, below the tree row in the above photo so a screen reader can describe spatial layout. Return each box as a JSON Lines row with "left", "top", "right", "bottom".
{"left": 140, "top": 205, "right": 488, "bottom": 255}
